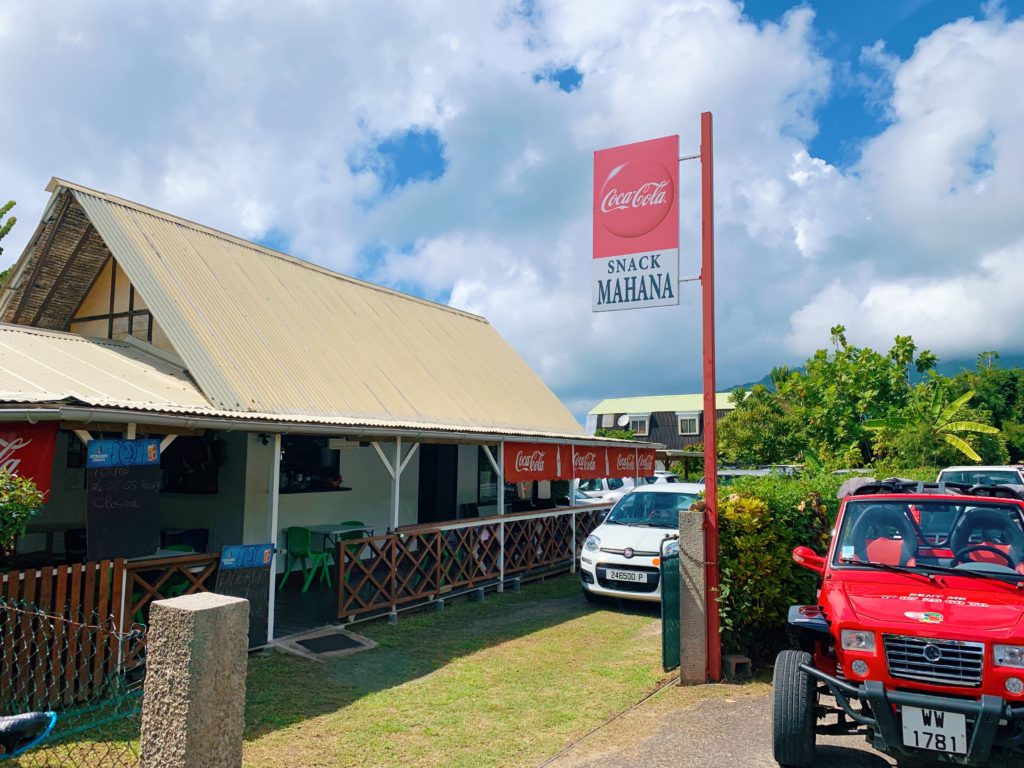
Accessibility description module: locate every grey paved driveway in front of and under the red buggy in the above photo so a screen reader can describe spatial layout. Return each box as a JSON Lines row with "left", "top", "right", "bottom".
{"left": 545, "top": 684, "right": 895, "bottom": 768}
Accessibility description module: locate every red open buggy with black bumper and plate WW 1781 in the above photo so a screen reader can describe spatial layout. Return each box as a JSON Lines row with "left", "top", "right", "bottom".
{"left": 772, "top": 480, "right": 1024, "bottom": 768}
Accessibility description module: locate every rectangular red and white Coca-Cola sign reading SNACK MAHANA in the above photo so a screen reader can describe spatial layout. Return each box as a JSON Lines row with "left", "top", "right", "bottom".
{"left": 591, "top": 136, "right": 679, "bottom": 312}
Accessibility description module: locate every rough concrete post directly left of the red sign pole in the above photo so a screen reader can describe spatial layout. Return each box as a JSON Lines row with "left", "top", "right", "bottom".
{"left": 679, "top": 511, "right": 708, "bottom": 685}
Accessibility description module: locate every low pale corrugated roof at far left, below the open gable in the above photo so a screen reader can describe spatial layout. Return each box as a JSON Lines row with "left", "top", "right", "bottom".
{"left": 0, "top": 325, "right": 215, "bottom": 414}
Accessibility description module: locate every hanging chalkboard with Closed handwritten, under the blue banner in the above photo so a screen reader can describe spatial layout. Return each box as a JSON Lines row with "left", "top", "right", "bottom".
{"left": 86, "top": 465, "right": 160, "bottom": 560}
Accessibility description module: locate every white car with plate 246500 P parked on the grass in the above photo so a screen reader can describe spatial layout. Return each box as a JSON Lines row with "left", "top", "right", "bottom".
{"left": 580, "top": 482, "right": 703, "bottom": 601}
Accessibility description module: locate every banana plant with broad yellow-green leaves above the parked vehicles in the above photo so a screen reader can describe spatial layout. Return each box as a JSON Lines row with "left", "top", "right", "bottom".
{"left": 864, "top": 376, "right": 999, "bottom": 462}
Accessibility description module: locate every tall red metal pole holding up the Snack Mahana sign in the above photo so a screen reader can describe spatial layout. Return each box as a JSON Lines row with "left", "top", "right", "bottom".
{"left": 700, "top": 112, "right": 722, "bottom": 683}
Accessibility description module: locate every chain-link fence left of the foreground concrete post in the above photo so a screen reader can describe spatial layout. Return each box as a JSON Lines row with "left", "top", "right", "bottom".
{"left": 0, "top": 599, "right": 145, "bottom": 768}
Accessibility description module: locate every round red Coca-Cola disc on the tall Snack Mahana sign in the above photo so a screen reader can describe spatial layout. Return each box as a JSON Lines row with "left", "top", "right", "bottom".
{"left": 600, "top": 160, "right": 676, "bottom": 238}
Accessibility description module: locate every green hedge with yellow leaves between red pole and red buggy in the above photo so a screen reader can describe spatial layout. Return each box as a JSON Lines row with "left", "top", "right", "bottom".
{"left": 718, "top": 473, "right": 843, "bottom": 657}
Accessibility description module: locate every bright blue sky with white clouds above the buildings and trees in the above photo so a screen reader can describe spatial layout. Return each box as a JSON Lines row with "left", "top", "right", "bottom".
{"left": 0, "top": 0, "right": 1024, "bottom": 415}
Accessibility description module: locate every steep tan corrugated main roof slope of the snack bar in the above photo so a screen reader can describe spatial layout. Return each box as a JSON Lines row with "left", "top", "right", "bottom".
{"left": 50, "top": 179, "right": 584, "bottom": 435}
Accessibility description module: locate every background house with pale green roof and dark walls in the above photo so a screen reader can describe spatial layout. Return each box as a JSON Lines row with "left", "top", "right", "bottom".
{"left": 587, "top": 392, "right": 735, "bottom": 451}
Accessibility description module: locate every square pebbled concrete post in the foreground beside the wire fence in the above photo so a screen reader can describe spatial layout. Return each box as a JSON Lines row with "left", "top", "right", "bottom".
{"left": 141, "top": 592, "right": 249, "bottom": 768}
